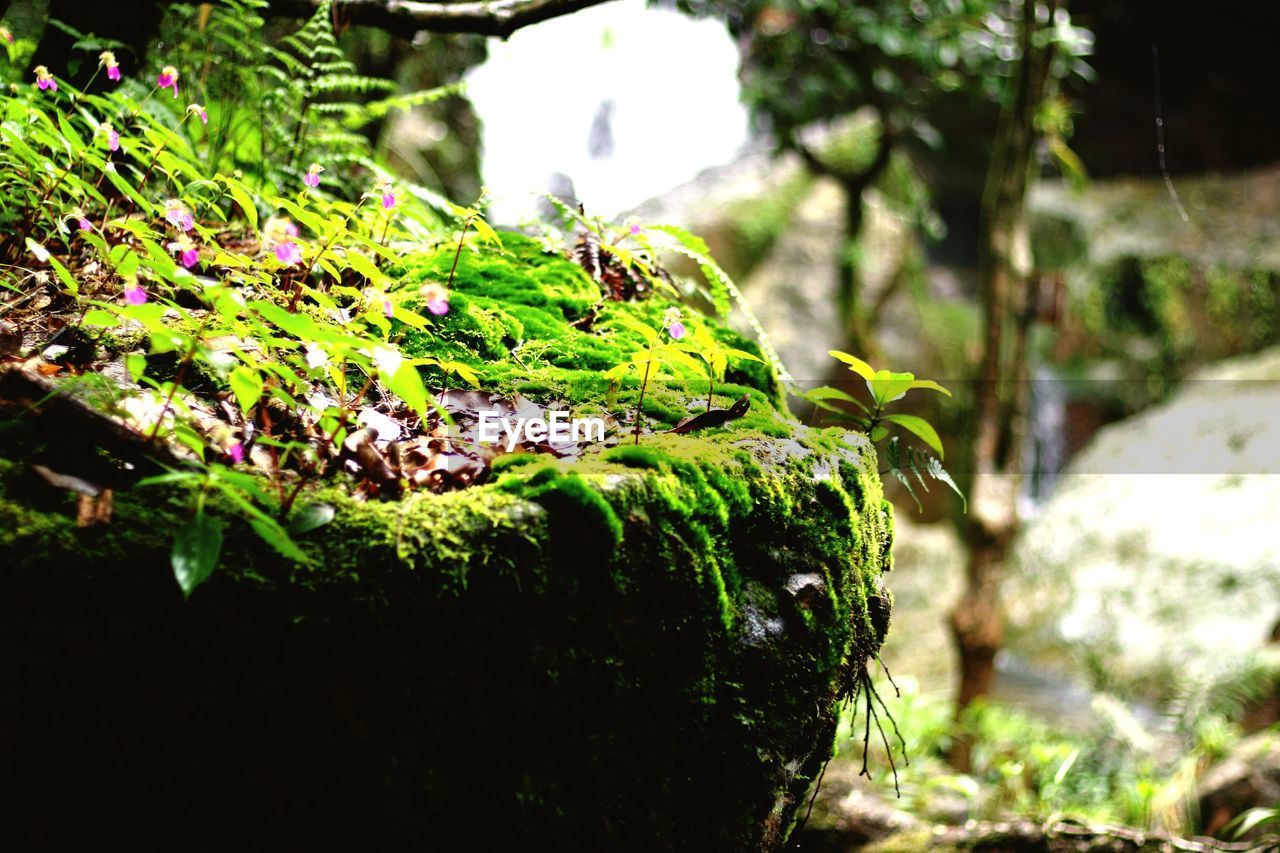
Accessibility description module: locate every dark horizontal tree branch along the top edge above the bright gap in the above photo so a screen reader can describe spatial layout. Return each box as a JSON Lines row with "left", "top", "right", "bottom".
{"left": 270, "top": 0, "right": 624, "bottom": 38}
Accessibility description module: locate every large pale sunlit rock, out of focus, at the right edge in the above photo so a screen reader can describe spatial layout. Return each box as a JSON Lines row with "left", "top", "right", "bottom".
{"left": 1006, "top": 348, "right": 1280, "bottom": 690}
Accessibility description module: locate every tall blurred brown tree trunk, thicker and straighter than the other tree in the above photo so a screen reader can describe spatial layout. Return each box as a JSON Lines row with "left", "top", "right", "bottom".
{"left": 951, "top": 0, "right": 1059, "bottom": 770}
